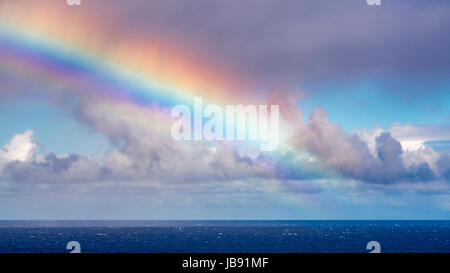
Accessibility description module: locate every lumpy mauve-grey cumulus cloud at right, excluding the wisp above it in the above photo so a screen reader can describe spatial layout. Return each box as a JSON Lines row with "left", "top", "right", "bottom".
{"left": 284, "top": 103, "right": 448, "bottom": 184}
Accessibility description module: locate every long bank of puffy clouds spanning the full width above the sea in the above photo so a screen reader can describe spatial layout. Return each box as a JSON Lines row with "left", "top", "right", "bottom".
{"left": 0, "top": 88, "right": 450, "bottom": 199}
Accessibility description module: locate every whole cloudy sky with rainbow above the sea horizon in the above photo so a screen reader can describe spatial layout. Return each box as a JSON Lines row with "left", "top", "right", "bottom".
{"left": 0, "top": 0, "right": 450, "bottom": 220}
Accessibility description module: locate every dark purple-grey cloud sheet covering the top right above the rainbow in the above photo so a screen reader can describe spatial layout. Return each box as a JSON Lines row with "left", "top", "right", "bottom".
{"left": 94, "top": 0, "right": 450, "bottom": 84}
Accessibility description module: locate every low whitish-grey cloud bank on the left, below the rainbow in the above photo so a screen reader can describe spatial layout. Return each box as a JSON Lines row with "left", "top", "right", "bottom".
{"left": 0, "top": 124, "right": 274, "bottom": 184}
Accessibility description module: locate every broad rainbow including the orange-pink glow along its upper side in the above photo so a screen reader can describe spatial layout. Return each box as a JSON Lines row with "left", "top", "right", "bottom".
{"left": 0, "top": 1, "right": 250, "bottom": 106}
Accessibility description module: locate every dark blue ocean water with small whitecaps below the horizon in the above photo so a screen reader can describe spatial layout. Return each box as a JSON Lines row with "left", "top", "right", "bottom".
{"left": 0, "top": 221, "right": 450, "bottom": 253}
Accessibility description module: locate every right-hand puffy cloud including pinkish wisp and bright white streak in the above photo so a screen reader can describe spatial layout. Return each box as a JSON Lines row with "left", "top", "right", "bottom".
{"left": 270, "top": 94, "right": 449, "bottom": 184}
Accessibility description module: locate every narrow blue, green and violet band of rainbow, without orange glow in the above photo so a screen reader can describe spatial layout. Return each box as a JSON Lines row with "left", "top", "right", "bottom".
{"left": 0, "top": 22, "right": 211, "bottom": 106}
